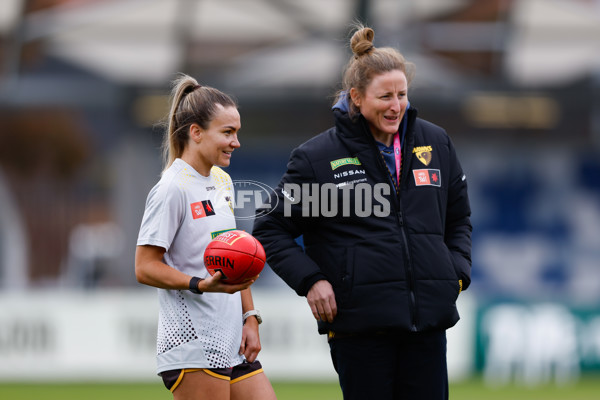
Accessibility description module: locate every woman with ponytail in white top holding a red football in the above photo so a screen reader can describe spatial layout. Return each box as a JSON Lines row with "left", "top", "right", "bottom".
{"left": 135, "top": 75, "right": 275, "bottom": 400}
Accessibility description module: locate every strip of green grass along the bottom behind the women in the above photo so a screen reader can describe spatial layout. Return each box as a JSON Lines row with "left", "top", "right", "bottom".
{"left": 0, "top": 376, "right": 600, "bottom": 400}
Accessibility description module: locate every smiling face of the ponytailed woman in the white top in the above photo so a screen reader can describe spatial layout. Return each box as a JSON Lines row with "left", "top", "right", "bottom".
{"left": 181, "top": 104, "right": 241, "bottom": 176}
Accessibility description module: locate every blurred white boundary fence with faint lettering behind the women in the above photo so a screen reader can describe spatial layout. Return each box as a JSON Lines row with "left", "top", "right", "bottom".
{"left": 0, "top": 289, "right": 475, "bottom": 382}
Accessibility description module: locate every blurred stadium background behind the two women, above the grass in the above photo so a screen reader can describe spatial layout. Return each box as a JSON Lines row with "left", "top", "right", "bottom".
{"left": 0, "top": 0, "right": 600, "bottom": 391}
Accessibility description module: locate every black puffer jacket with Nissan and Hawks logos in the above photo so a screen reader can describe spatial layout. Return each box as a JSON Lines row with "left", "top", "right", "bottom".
{"left": 253, "top": 104, "right": 471, "bottom": 333}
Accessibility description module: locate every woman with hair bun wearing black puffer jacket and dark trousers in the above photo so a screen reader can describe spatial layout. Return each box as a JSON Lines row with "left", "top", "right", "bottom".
{"left": 253, "top": 27, "right": 471, "bottom": 400}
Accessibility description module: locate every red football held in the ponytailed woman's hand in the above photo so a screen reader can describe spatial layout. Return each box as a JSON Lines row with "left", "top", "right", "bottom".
{"left": 204, "top": 230, "right": 266, "bottom": 284}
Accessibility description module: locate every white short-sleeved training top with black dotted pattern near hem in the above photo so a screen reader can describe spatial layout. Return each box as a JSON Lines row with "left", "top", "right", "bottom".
{"left": 137, "top": 158, "right": 243, "bottom": 373}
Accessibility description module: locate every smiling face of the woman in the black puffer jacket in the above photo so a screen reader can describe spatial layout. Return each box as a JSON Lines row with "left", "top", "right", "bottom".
{"left": 350, "top": 70, "right": 408, "bottom": 146}
